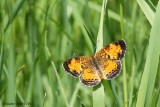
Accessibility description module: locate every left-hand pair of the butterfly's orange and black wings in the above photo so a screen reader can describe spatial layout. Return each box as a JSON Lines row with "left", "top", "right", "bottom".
{"left": 63, "top": 56, "right": 101, "bottom": 86}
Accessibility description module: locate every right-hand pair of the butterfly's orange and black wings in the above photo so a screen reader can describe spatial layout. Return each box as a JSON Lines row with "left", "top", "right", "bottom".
{"left": 94, "top": 40, "right": 126, "bottom": 79}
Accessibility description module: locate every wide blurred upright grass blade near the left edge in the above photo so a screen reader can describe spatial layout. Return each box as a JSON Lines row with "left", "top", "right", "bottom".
{"left": 6, "top": 2, "right": 16, "bottom": 107}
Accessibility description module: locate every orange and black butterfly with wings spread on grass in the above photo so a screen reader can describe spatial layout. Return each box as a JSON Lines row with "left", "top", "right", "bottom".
{"left": 63, "top": 40, "right": 126, "bottom": 86}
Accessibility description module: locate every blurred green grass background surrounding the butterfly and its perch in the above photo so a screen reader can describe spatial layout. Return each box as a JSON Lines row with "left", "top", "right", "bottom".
{"left": 0, "top": 0, "right": 160, "bottom": 107}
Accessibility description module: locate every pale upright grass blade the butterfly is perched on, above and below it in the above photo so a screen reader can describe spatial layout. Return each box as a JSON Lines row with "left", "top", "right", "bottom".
{"left": 93, "top": 0, "right": 108, "bottom": 107}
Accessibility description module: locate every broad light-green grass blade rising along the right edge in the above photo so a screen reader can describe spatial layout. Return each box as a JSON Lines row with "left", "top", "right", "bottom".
{"left": 136, "top": 2, "right": 160, "bottom": 107}
